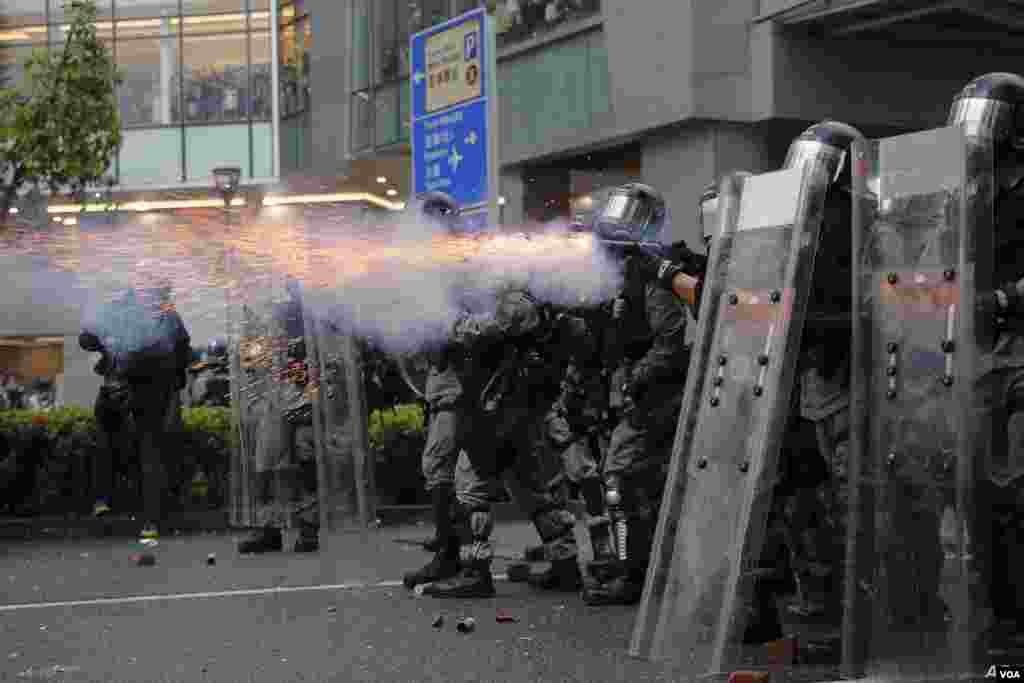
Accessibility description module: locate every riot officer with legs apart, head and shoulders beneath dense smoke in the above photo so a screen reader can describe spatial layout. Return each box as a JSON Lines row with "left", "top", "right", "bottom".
{"left": 424, "top": 284, "right": 582, "bottom": 598}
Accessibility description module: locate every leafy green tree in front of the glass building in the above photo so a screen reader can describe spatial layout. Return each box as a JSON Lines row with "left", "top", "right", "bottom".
{"left": 0, "top": 0, "right": 121, "bottom": 223}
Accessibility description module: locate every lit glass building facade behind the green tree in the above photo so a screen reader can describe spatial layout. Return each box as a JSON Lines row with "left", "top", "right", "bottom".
{"left": 0, "top": 0, "right": 276, "bottom": 188}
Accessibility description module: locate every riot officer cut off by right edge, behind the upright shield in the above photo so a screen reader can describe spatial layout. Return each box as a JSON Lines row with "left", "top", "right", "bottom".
{"left": 935, "top": 73, "right": 1024, "bottom": 651}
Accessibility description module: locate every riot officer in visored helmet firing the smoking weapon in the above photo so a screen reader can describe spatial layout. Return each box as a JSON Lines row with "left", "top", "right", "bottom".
{"left": 583, "top": 183, "right": 688, "bottom": 605}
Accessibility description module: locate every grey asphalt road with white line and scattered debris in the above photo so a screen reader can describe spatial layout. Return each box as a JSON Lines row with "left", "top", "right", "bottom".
{"left": 0, "top": 524, "right": 688, "bottom": 683}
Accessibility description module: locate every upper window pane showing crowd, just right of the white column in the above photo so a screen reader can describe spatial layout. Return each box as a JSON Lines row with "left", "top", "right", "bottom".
{"left": 184, "top": 34, "right": 249, "bottom": 122}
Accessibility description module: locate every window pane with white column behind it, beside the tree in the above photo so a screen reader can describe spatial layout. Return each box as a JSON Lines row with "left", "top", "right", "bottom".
{"left": 117, "top": 37, "right": 180, "bottom": 126}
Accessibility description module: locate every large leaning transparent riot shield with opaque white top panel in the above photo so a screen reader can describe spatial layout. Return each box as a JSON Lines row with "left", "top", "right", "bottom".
{"left": 632, "top": 160, "right": 829, "bottom": 680}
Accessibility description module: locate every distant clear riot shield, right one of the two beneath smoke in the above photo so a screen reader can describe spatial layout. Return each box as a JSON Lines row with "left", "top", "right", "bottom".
{"left": 304, "top": 292, "right": 376, "bottom": 531}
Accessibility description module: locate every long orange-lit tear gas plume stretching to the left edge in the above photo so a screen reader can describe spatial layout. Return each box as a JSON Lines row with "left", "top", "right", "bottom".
{"left": 3, "top": 210, "right": 622, "bottom": 353}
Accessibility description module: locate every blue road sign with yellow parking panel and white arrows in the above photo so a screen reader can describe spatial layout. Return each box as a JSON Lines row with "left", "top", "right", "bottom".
{"left": 410, "top": 8, "right": 494, "bottom": 207}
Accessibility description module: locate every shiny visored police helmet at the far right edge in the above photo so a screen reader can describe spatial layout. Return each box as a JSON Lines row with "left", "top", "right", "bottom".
{"left": 946, "top": 73, "right": 1024, "bottom": 150}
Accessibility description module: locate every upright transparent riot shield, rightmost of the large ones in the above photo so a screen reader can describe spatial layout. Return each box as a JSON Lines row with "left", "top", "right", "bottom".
{"left": 847, "top": 127, "right": 993, "bottom": 681}
